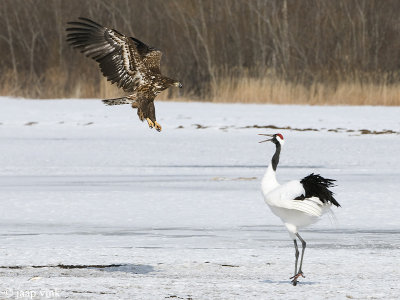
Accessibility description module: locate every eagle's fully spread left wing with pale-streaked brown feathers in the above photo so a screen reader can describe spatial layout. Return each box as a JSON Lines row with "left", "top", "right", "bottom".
{"left": 67, "top": 18, "right": 147, "bottom": 92}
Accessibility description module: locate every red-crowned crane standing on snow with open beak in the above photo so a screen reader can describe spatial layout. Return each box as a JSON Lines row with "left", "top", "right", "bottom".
{"left": 260, "top": 133, "right": 340, "bottom": 285}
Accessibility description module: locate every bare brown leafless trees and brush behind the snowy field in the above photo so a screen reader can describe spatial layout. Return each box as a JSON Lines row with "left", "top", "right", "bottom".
{"left": 0, "top": 0, "right": 400, "bottom": 104}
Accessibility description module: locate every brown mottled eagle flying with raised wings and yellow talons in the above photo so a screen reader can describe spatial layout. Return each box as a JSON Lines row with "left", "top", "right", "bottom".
{"left": 67, "top": 18, "right": 182, "bottom": 131}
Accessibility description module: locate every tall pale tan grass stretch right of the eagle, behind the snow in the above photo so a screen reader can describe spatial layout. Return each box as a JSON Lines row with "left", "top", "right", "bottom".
{"left": 211, "top": 77, "right": 400, "bottom": 106}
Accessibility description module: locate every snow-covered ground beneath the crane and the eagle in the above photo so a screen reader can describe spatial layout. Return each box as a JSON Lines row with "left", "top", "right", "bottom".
{"left": 0, "top": 97, "right": 400, "bottom": 300}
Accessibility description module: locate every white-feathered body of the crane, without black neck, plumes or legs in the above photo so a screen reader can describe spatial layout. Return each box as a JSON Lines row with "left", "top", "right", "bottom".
{"left": 261, "top": 164, "right": 330, "bottom": 239}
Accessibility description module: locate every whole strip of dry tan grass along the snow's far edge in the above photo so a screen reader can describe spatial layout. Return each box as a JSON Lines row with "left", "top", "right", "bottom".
{"left": 0, "top": 69, "right": 400, "bottom": 106}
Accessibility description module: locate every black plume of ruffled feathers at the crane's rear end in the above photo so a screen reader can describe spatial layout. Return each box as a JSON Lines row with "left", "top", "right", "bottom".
{"left": 297, "top": 173, "right": 340, "bottom": 207}
